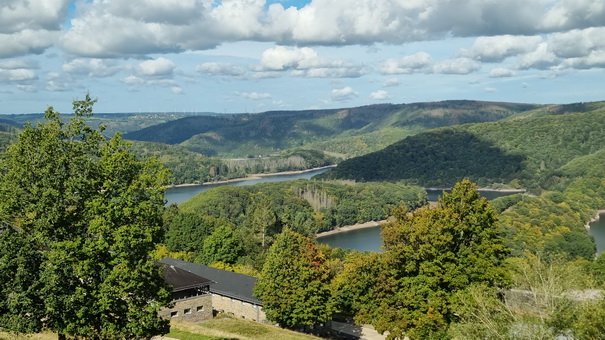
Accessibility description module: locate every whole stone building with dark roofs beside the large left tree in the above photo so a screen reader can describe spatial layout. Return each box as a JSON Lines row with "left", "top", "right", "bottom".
{"left": 158, "top": 258, "right": 267, "bottom": 322}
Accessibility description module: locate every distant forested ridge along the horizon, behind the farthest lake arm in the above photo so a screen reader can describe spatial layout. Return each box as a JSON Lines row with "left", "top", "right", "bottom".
{"left": 125, "top": 101, "right": 544, "bottom": 157}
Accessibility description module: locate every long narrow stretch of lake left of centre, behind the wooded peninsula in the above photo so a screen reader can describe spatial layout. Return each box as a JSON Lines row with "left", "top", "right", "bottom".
{"left": 164, "top": 168, "right": 330, "bottom": 204}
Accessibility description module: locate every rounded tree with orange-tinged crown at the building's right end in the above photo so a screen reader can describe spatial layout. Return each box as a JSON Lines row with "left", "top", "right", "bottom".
{"left": 254, "top": 229, "right": 332, "bottom": 328}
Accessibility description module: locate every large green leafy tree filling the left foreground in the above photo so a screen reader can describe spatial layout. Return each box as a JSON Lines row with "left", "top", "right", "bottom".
{"left": 0, "top": 95, "right": 170, "bottom": 339}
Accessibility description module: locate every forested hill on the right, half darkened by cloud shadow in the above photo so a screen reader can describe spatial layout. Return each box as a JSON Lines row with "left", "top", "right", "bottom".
{"left": 325, "top": 102, "right": 605, "bottom": 188}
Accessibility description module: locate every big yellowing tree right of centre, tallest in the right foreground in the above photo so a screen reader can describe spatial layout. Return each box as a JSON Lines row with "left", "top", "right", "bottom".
{"left": 336, "top": 180, "right": 508, "bottom": 339}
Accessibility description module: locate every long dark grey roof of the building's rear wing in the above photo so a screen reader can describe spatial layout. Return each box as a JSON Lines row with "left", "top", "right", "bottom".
{"left": 160, "top": 257, "right": 263, "bottom": 306}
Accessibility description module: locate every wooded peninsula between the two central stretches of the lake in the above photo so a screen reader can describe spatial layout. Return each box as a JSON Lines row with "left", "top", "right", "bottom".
{"left": 160, "top": 180, "right": 427, "bottom": 269}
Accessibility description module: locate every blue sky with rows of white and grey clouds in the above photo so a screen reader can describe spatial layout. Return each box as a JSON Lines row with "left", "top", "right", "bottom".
{"left": 0, "top": 0, "right": 605, "bottom": 114}
